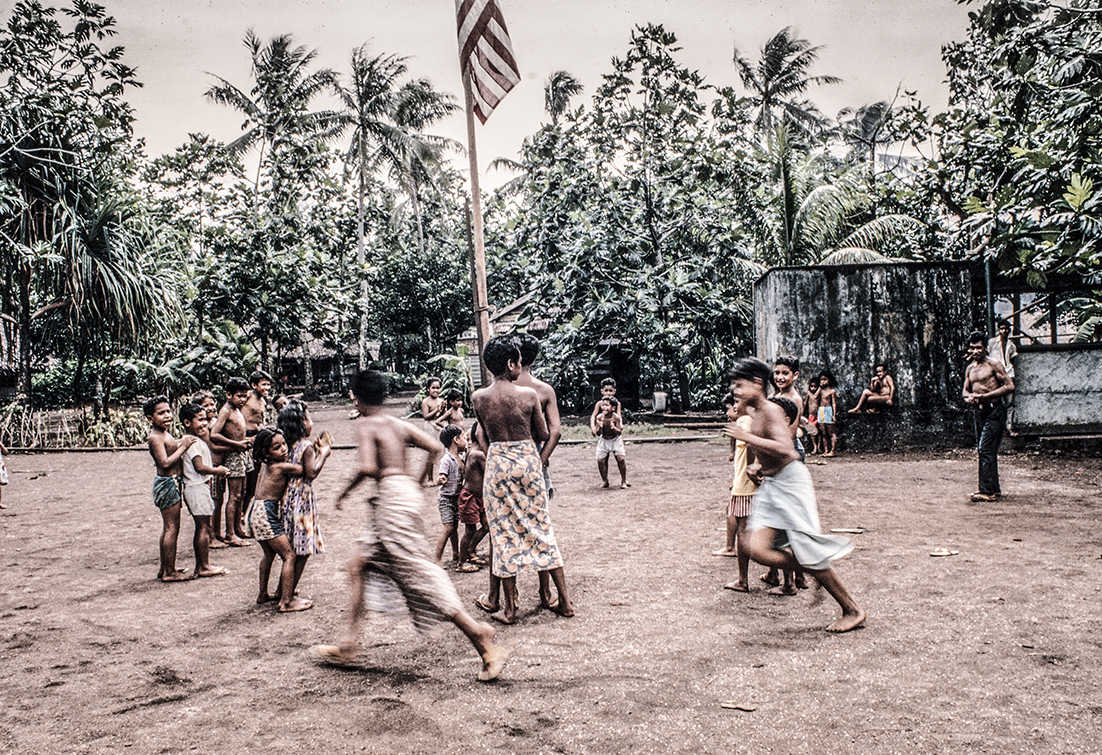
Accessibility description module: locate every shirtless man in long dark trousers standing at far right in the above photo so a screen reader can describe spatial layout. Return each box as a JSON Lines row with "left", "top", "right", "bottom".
{"left": 961, "top": 333, "right": 1014, "bottom": 503}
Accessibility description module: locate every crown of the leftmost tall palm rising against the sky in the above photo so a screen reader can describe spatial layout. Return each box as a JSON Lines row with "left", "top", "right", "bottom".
{"left": 206, "top": 29, "right": 337, "bottom": 197}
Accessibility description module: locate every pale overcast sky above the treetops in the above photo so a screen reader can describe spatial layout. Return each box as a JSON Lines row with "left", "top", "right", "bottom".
{"left": 0, "top": 0, "right": 968, "bottom": 187}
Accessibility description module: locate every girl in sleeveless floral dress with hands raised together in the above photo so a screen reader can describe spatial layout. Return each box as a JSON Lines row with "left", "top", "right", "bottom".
{"left": 276, "top": 401, "right": 333, "bottom": 593}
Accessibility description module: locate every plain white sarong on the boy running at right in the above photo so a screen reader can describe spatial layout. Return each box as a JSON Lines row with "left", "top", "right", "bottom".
{"left": 746, "top": 462, "right": 853, "bottom": 569}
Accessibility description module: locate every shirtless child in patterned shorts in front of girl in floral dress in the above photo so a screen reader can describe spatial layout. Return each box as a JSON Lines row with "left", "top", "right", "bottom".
{"left": 247, "top": 428, "right": 314, "bottom": 613}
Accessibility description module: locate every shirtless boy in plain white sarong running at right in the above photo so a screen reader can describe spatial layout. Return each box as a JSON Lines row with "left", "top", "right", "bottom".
{"left": 724, "top": 358, "right": 865, "bottom": 632}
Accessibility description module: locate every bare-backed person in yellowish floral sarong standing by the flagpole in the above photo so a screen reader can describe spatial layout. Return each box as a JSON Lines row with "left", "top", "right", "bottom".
{"left": 471, "top": 336, "right": 574, "bottom": 624}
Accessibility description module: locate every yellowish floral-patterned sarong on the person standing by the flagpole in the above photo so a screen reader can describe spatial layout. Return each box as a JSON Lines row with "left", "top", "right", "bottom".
{"left": 483, "top": 441, "right": 562, "bottom": 576}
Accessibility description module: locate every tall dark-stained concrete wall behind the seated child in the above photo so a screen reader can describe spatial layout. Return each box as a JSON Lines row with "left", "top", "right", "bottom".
{"left": 754, "top": 262, "right": 973, "bottom": 447}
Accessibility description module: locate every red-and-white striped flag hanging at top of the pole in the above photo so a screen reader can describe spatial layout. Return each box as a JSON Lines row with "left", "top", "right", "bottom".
{"left": 455, "top": 0, "right": 520, "bottom": 123}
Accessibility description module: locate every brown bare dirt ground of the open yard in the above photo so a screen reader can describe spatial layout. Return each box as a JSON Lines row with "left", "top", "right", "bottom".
{"left": 0, "top": 396, "right": 1102, "bottom": 753}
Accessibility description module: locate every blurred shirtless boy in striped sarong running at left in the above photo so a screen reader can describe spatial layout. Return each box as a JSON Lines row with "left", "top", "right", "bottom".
{"left": 310, "top": 370, "right": 508, "bottom": 681}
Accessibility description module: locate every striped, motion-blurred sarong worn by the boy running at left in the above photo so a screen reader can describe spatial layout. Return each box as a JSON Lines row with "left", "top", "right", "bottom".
{"left": 359, "top": 475, "right": 463, "bottom": 632}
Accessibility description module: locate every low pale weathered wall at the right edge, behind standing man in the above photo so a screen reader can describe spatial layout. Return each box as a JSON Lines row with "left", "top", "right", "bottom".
{"left": 1014, "top": 344, "right": 1102, "bottom": 434}
